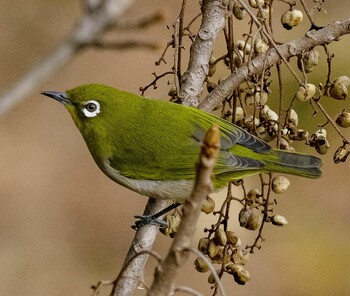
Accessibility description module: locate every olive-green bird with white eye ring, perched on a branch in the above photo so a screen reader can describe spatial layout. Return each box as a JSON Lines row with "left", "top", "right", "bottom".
{"left": 42, "top": 84, "right": 322, "bottom": 202}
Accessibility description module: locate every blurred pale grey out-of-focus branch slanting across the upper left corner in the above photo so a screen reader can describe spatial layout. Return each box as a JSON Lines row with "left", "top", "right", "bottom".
{"left": 0, "top": 0, "right": 134, "bottom": 116}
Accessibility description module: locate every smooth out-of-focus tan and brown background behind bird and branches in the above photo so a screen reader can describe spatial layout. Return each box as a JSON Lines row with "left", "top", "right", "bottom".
{"left": 0, "top": 0, "right": 350, "bottom": 296}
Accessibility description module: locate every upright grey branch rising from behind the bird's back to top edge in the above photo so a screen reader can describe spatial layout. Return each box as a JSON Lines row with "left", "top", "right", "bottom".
{"left": 179, "top": 0, "right": 227, "bottom": 106}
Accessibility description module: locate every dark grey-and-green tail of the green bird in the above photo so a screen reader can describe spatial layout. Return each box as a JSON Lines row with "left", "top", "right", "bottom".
{"left": 265, "top": 150, "right": 322, "bottom": 178}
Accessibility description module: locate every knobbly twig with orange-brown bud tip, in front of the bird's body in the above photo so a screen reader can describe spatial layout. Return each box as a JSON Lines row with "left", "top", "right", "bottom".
{"left": 147, "top": 126, "right": 220, "bottom": 296}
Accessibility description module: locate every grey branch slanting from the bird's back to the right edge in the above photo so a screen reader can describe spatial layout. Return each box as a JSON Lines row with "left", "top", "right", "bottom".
{"left": 199, "top": 18, "right": 350, "bottom": 111}
